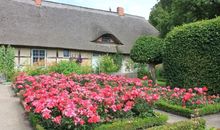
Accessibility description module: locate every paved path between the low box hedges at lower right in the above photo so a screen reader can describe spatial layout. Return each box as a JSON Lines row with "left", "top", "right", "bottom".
{"left": 155, "top": 110, "right": 220, "bottom": 128}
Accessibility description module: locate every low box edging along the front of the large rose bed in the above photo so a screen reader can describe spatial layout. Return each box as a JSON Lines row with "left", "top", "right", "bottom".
{"left": 28, "top": 113, "right": 168, "bottom": 130}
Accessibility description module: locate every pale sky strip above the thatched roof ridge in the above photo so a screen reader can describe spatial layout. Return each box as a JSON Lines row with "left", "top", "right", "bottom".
{"left": 49, "top": 0, "right": 158, "bottom": 19}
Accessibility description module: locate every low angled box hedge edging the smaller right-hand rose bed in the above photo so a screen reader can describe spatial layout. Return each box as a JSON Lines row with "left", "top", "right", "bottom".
{"left": 155, "top": 101, "right": 220, "bottom": 118}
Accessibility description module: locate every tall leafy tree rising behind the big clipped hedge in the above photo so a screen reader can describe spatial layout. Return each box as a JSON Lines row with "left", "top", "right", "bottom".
{"left": 149, "top": 0, "right": 220, "bottom": 37}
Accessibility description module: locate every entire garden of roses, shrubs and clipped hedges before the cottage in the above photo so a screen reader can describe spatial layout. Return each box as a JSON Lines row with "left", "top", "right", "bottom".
{"left": 0, "top": 3, "right": 220, "bottom": 130}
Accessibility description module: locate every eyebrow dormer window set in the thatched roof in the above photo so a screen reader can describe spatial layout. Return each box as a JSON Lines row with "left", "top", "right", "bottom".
{"left": 93, "top": 34, "right": 122, "bottom": 44}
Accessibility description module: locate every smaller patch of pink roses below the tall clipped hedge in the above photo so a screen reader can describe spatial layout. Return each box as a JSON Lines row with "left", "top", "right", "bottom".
{"left": 152, "top": 86, "right": 220, "bottom": 109}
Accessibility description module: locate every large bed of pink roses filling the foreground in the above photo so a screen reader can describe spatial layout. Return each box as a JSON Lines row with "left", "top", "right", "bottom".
{"left": 15, "top": 73, "right": 165, "bottom": 130}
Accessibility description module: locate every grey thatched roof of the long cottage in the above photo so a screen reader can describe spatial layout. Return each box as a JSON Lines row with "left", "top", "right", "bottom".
{"left": 0, "top": 0, "right": 158, "bottom": 54}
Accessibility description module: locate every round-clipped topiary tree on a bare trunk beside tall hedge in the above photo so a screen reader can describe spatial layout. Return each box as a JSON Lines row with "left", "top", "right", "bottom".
{"left": 130, "top": 36, "right": 163, "bottom": 83}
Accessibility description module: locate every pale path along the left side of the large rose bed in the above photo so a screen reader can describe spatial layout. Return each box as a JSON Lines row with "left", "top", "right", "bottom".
{"left": 0, "top": 84, "right": 32, "bottom": 130}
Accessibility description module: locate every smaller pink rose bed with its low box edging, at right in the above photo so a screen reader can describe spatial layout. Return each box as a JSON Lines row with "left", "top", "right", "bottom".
{"left": 152, "top": 87, "right": 220, "bottom": 118}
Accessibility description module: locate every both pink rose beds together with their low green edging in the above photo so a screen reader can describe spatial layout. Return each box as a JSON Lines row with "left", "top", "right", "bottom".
{"left": 14, "top": 73, "right": 217, "bottom": 130}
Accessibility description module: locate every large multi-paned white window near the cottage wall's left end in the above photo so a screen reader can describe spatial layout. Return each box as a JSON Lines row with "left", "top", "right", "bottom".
{"left": 32, "top": 49, "right": 45, "bottom": 64}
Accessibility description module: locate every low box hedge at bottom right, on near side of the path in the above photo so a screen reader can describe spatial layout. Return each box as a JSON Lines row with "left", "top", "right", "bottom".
{"left": 148, "top": 118, "right": 206, "bottom": 130}
